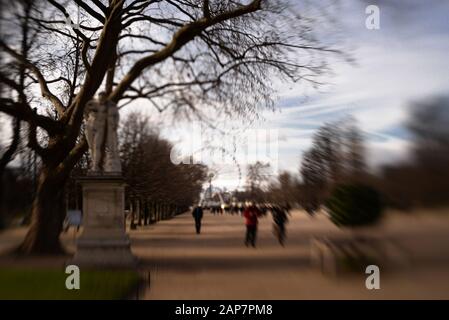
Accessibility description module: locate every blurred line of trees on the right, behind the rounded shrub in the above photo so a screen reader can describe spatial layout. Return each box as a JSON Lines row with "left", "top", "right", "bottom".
{"left": 242, "top": 96, "right": 449, "bottom": 212}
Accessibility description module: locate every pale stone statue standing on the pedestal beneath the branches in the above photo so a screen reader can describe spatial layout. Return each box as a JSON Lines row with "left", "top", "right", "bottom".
{"left": 86, "top": 92, "right": 122, "bottom": 174}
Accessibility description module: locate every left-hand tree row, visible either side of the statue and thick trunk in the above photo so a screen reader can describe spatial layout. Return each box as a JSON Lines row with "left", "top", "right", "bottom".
{"left": 0, "top": 113, "right": 207, "bottom": 225}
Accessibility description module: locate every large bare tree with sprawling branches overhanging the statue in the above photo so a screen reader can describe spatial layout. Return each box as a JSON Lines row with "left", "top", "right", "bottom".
{"left": 0, "top": 0, "right": 336, "bottom": 253}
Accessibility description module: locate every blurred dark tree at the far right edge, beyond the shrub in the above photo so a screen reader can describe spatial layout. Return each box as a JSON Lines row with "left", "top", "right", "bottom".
{"left": 380, "top": 96, "right": 449, "bottom": 209}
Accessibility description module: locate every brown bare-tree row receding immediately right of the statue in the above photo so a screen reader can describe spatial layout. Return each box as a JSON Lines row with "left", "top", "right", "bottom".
{"left": 119, "top": 113, "right": 207, "bottom": 225}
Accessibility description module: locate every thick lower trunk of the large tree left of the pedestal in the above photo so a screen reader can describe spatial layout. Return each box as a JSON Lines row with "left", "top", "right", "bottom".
{"left": 19, "top": 167, "right": 66, "bottom": 254}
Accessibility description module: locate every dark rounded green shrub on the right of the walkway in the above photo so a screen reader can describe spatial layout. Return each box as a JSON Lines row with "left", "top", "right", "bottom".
{"left": 326, "top": 185, "right": 383, "bottom": 227}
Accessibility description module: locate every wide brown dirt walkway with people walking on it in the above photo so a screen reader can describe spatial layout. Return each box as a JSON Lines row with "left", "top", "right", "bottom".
{"left": 132, "top": 211, "right": 449, "bottom": 299}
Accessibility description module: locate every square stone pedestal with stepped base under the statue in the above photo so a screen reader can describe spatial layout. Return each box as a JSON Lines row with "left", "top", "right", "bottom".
{"left": 71, "top": 175, "right": 137, "bottom": 268}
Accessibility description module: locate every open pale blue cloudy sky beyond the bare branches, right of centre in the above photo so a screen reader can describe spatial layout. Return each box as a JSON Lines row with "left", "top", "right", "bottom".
{"left": 169, "top": 0, "right": 449, "bottom": 188}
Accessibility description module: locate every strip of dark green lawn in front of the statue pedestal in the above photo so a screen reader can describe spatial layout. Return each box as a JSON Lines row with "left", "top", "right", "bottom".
{"left": 0, "top": 267, "right": 139, "bottom": 300}
